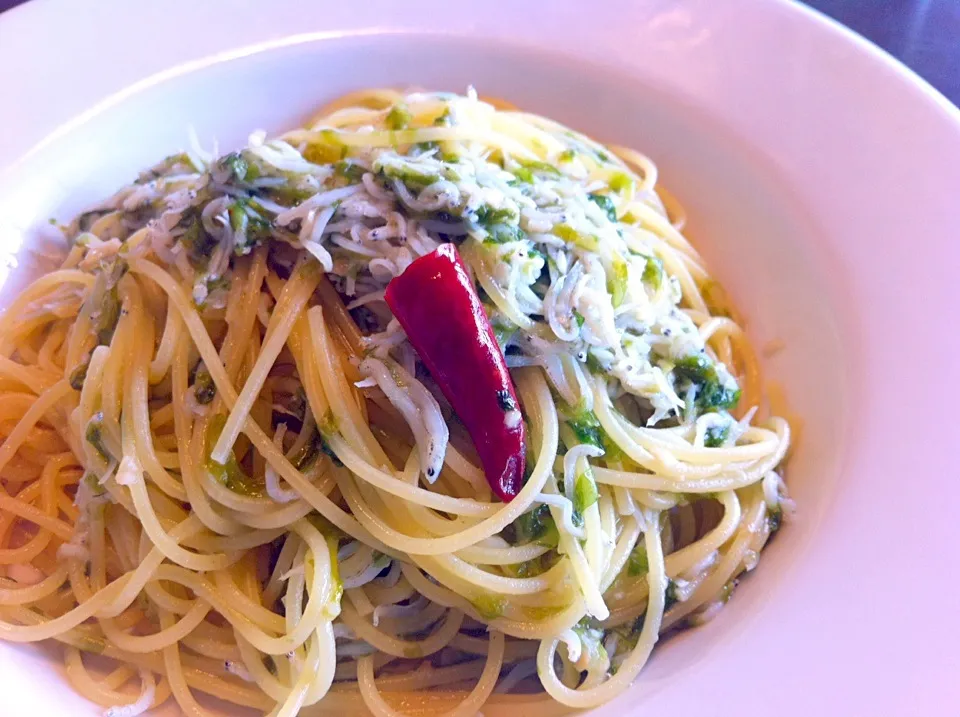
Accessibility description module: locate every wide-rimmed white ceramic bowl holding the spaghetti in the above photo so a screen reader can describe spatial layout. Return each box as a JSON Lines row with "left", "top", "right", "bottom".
{"left": 0, "top": 0, "right": 960, "bottom": 715}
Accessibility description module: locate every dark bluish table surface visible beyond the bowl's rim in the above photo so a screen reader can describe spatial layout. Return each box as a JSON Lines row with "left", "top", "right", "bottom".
{"left": 0, "top": 0, "right": 960, "bottom": 105}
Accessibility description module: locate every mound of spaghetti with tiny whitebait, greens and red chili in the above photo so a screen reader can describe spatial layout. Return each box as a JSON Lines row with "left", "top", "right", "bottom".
{"left": 0, "top": 90, "right": 791, "bottom": 717}
